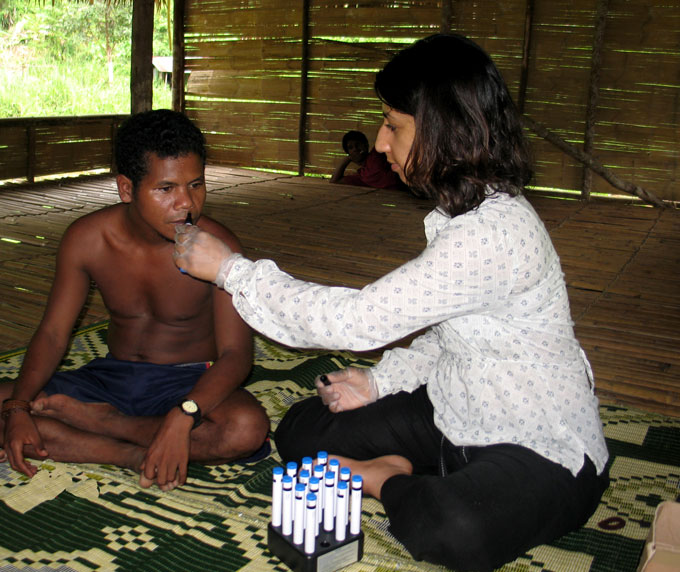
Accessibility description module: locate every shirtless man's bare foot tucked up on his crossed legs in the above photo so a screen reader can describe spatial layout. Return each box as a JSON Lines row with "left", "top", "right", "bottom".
{"left": 31, "top": 393, "right": 121, "bottom": 435}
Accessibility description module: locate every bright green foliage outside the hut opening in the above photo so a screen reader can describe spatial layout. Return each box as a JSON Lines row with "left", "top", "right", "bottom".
{"left": 0, "top": 0, "right": 172, "bottom": 117}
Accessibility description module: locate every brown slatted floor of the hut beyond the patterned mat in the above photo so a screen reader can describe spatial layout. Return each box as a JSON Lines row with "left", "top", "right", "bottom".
{"left": 0, "top": 167, "right": 680, "bottom": 416}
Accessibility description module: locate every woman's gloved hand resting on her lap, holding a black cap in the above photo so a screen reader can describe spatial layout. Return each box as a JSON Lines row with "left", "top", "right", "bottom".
{"left": 315, "top": 367, "right": 378, "bottom": 413}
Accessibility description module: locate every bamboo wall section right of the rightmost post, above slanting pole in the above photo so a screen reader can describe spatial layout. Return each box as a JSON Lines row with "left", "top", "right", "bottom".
{"left": 595, "top": 0, "right": 680, "bottom": 200}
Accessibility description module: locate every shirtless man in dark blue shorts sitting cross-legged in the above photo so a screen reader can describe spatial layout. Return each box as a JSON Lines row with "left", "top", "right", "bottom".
{"left": 0, "top": 110, "right": 269, "bottom": 490}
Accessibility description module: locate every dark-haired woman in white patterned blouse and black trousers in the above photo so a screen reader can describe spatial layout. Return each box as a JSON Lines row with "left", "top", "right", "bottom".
{"left": 175, "top": 35, "right": 608, "bottom": 570}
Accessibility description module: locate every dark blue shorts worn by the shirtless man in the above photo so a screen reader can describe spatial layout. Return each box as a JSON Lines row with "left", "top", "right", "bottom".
{"left": 43, "top": 356, "right": 210, "bottom": 416}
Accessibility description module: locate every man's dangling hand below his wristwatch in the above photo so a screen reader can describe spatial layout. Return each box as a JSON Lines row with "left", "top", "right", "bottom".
{"left": 139, "top": 407, "right": 194, "bottom": 491}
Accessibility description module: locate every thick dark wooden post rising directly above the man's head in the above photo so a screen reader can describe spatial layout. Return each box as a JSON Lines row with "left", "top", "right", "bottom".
{"left": 130, "top": 0, "right": 154, "bottom": 113}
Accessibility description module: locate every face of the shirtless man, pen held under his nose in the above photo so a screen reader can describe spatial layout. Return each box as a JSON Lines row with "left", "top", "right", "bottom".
{"left": 121, "top": 153, "right": 206, "bottom": 240}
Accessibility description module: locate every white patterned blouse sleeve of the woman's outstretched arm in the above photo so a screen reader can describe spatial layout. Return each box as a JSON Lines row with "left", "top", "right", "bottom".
{"left": 224, "top": 210, "right": 512, "bottom": 351}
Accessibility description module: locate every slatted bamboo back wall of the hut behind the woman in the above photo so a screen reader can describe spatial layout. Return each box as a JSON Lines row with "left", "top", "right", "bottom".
{"left": 184, "top": 0, "right": 680, "bottom": 200}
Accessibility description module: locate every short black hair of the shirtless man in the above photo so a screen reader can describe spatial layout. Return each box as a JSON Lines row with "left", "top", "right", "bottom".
{"left": 115, "top": 109, "right": 206, "bottom": 189}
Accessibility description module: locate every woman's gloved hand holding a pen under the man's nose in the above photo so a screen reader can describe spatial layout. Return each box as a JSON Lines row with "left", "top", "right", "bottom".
{"left": 172, "top": 224, "right": 233, "bottom": 282}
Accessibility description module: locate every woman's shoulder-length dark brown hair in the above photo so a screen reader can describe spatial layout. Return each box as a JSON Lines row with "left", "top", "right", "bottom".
{"left": 375, "top": 34, "right": 532, "bottom": 216}
